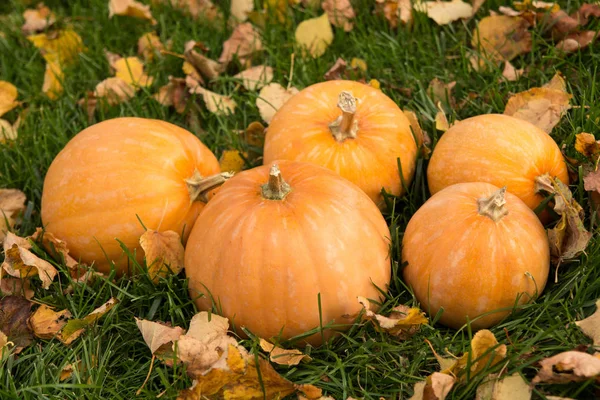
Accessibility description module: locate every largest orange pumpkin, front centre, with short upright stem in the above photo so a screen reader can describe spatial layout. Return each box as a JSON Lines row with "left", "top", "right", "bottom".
{"left": 185, "top": 161, "right": 391, "bottom": 344}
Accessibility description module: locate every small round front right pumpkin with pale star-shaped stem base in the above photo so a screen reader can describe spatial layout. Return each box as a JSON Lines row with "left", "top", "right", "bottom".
{"left": 402, "top": 182, "right": 550, "bottom": 329}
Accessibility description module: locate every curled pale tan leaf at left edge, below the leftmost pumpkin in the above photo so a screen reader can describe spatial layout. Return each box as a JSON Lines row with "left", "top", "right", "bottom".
{"left": 2, "top": 232, "right": 58, "bottom": 289}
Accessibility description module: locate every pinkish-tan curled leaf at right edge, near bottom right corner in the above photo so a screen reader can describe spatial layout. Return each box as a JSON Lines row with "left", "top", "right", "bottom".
{"left": 531, "top": 351, "right": 600, "bottom": 385}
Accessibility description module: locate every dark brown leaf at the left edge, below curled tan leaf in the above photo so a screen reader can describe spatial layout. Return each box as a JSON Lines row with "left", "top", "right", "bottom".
{"left": 0, "top": 296, "right": 33, "bottom": 354}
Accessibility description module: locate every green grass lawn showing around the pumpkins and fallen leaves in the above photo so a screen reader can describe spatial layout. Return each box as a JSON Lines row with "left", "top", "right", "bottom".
{"left": 0, "top": 0, "right": 600, "bottom": 399}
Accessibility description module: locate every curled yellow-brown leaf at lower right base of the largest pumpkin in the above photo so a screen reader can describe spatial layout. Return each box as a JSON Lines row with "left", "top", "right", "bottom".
{"left": 358, "top": 296, "right": 427, "bottom": 339}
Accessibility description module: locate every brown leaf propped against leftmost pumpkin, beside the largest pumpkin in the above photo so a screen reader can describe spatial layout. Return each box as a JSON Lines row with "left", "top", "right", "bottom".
{"left": 140, "top": 229, "right": 184, "bottom": 283}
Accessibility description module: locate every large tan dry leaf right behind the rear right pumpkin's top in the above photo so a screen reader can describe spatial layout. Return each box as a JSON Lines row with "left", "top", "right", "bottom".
{"left": 504, "top": 74, "right": 573, "bottom": 133}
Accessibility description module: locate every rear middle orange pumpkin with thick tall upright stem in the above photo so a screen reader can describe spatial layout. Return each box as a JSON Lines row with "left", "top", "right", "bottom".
{"left": 264, "top": 80, "right": 417, "bottom": 206}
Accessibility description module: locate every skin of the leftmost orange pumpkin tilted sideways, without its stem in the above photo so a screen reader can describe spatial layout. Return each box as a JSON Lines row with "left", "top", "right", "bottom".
{"left": 42, "top": 118, "right": 219, "bottom": 275}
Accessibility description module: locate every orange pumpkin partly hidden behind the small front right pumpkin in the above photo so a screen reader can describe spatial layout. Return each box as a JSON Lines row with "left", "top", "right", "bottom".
{"left": 427, "top": 114, "right": 569, "bottom": 217}
